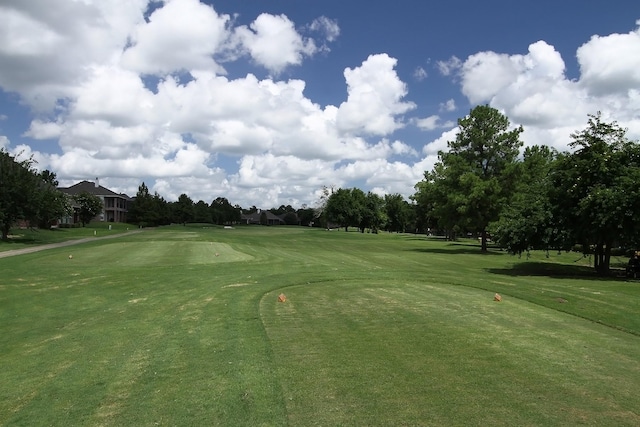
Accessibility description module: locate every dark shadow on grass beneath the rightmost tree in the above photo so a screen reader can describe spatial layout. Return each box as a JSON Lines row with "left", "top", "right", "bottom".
{"left": 486, "top": 261, "right": 625, "bottom": 281}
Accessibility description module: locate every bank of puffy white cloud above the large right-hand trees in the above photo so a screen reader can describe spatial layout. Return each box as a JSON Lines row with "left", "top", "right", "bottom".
{"left": 450, "top": 31, "right": 640, "bottom": 150}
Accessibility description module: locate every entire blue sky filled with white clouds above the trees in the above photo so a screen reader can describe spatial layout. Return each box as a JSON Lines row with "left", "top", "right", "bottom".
{"left": 0, "top": 0, "right": 640, "bottom": 209}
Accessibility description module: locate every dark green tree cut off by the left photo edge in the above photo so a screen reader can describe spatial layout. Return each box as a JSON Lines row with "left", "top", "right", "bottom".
{"left": 0, "top": 149, "right": 38, "bottom": 240}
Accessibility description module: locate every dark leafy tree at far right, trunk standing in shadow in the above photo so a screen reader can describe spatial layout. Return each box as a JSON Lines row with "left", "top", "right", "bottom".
{"left": 551, "top": 113, "right": 640, "bottom": 274}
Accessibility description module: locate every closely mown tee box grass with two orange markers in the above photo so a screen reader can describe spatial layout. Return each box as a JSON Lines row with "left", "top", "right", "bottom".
{"left": 262, "top": 282, "right": 640, "bottom": 425}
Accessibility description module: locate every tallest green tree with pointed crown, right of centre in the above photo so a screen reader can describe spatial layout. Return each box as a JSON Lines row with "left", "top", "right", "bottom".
{"left": 419, "top": 105, "right": 523, "bottom": 252}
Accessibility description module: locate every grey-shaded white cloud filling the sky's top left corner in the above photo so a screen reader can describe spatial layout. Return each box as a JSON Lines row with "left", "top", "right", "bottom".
{"left": 0, "top": 0, "right": 147, "bottom": 111}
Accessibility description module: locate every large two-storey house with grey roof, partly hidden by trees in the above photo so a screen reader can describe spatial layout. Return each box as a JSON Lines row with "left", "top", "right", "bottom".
{"left": 58, "top": 178, "right": 132, "bottom": 224}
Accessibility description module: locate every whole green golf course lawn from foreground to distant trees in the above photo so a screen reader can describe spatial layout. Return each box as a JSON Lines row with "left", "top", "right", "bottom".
{"left": 0, "top": 227, "right": 640, "bottom": 426}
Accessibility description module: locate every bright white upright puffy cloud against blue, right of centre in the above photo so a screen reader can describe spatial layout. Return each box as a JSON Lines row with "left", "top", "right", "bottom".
{"left": 336, "top": 54, "right": 415, "bottom": 135}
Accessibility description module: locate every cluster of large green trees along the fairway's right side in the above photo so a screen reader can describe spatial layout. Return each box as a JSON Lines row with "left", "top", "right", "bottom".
{"left": 412, "top": 105, "right": 640, "bottom": 274}
